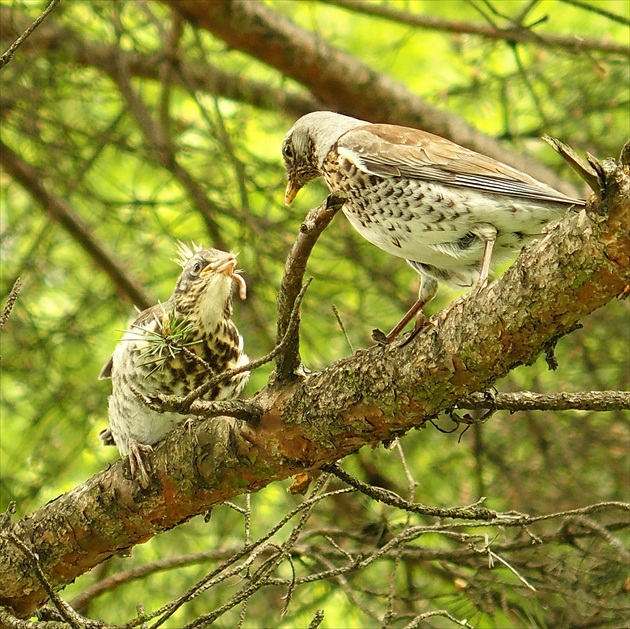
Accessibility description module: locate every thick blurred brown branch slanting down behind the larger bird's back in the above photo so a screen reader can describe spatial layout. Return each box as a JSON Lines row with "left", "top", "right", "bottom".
{"left": 163, "top": 0, "right": 577, "bottom": 196}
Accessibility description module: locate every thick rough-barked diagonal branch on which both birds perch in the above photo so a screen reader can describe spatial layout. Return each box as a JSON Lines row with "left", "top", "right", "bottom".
{"left": 0, "top": 155, "right": 630, "bottom": 616}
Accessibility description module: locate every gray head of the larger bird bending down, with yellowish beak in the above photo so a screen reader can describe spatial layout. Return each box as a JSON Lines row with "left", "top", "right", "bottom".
{"left": 282, "top": 111, "right": 369, "bottom": 205}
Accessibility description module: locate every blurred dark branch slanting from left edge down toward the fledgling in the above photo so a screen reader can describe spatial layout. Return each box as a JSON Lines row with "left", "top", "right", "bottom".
{"left": 0, "top": 140, "right": 155, "bottom": 310}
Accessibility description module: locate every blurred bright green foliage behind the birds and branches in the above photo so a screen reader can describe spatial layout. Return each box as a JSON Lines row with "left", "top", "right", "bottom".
{"left": 0, "top": 0, "right": 630, "bottom": 627}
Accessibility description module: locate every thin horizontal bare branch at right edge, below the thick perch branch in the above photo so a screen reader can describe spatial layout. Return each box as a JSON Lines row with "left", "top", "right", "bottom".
{"left": 457, "top": 391, "right": 630, "bottom": 413}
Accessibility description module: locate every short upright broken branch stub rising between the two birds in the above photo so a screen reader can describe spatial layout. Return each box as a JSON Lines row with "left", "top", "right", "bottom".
{"left": 269, "top": 197, "right": 343, "bottom": 386}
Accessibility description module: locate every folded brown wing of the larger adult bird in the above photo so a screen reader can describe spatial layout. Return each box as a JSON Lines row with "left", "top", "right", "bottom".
{"left": 337, "top": 124, "right": 584, "bottom": 205}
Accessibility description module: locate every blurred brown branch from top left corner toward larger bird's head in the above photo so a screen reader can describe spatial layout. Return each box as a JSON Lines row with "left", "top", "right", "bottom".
{"left": 0, "top": 6, "right": 323, "bottom": 118}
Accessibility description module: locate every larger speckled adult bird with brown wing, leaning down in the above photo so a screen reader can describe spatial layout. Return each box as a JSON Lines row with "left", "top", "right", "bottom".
{"left": 282, "top": 111, "right": 584, "bottom": 343}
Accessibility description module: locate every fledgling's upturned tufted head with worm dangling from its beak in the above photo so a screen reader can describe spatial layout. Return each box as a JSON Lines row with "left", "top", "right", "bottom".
{"left": 171, "top": 243, "right": 245, "bottom": 326}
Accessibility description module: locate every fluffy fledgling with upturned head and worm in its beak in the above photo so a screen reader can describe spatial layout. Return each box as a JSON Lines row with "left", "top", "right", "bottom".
{"left": 99, "top": 244, "right": 249, "bottom": 487}
